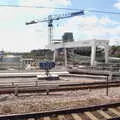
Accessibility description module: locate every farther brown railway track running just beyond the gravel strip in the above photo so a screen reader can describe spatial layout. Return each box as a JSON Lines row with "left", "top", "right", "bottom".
{"left": 0, "top": 81, "right": 120, "bottom": 95}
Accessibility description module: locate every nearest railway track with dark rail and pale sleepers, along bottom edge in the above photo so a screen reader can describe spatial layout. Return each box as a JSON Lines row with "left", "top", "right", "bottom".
{"left": 0, "top": 103, "right": 120, "bottom": 120}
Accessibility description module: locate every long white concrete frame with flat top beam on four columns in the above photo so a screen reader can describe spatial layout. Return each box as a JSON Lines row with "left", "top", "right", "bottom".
{"left": 47, "top": 39, "right": 109, "bottom": 67}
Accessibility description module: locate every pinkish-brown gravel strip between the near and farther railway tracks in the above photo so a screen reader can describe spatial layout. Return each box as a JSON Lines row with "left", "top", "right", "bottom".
{"left": 0, "top": 87, "right": 120, "bottom": 114}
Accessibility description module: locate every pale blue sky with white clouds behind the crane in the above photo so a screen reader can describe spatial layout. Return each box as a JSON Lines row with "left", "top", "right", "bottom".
{"left": 0, "top": 0, "right": 120, "bottom": 52}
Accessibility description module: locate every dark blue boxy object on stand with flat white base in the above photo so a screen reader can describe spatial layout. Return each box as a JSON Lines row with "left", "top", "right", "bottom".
{"left": 37, "top": 61, "right": 59, "bottom": 80}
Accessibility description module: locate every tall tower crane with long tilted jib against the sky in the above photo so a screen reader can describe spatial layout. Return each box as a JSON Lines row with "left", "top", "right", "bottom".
{"left": 25, "top": 10, "right": 84, "bottom": 44}
